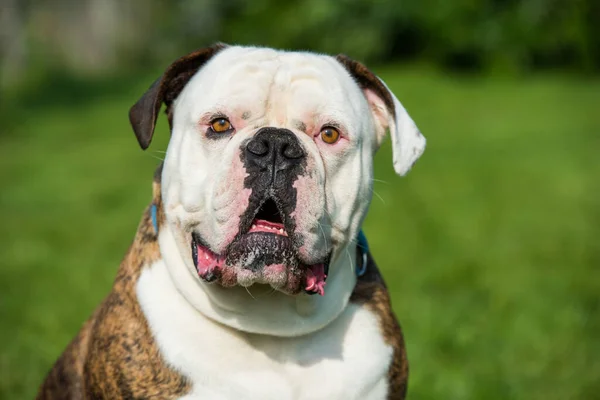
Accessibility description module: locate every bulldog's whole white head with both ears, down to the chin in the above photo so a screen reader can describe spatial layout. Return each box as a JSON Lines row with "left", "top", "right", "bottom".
{"left": 130, "top": 46, "right": 425, "bottom": 294}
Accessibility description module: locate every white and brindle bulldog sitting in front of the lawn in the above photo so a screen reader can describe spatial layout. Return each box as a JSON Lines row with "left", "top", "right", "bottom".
{"left": 37, "top": 43, "right": 426, "bottom": 400}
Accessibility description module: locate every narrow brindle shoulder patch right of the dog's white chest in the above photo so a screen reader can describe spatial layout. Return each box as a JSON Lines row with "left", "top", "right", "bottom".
{"left": 350, "top": 254, "right": 408, "bottom": 399}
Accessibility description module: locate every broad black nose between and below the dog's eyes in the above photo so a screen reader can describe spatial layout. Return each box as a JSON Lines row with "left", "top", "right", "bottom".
{"left": 246, "top": 128, "right": 306, "bottom": 174}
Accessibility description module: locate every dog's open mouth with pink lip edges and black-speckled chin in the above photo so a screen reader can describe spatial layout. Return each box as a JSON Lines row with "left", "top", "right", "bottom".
{"left": 191, "top": 198, "right": 330, "bottom": 295}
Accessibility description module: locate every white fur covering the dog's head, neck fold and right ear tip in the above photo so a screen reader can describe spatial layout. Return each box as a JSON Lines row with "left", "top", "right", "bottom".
{"left": 161, "top": 46, "right": 425, "bottom": 336}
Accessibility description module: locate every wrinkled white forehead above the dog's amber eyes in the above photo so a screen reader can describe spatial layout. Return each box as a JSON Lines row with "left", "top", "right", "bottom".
{"left": 180, "top": 47, "right": 366, "bottom": 128}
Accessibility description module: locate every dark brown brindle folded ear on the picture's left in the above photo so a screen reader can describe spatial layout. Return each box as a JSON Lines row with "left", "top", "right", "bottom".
{"left": 129, "top": 43, "right": 227, "bottom": 150}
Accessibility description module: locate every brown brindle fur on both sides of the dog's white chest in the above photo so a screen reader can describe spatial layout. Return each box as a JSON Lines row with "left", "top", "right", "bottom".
{"left": 37, "top": 171, "right": 408, "bottom": 400}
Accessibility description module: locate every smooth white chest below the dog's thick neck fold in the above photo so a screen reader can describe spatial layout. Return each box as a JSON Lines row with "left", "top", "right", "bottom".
{"left": 137, "top": 262, "right": 392, "bottom": 400}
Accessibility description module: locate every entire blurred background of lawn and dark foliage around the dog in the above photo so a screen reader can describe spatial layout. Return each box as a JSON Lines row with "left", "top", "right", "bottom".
{"left": 0, "top": 0, "right": 600, "bottom": 400}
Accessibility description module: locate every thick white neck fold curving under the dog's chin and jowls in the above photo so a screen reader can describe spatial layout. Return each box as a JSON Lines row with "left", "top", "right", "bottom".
{"left": 158, "top": 224, "right": 356, "bottom": 336}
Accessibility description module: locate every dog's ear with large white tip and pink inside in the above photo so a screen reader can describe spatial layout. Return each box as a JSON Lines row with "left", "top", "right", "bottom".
{"left": 336, "top": 54, "right": 426, "bottom": 176}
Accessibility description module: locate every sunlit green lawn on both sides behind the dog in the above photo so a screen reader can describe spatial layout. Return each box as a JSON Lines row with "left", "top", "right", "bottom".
{"left": 0, "top": 68, "right": 600, "bottom": 400}
